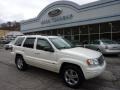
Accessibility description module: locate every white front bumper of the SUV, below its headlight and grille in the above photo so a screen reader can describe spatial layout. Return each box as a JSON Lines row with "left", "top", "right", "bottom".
{"left": 83, "top": 61, "right": 106, "bottom": 79}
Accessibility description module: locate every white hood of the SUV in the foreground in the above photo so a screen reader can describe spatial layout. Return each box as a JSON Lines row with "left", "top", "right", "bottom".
{"left": 61, "top": 47, "right": 102, "bottom": 59}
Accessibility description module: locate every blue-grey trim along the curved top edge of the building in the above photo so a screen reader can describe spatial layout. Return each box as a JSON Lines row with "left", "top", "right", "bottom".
{"left": 20, "top": 0, "right": 119, "bottom": 24}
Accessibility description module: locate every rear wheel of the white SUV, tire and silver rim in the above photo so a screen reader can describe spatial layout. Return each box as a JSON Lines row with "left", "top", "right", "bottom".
{"left": 15, "top": 56, "right": 27, "bottom": 71}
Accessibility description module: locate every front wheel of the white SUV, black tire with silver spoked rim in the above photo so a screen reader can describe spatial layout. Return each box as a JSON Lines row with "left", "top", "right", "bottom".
{"left": 61, "top": 65, "right": 85, "bottom": 88}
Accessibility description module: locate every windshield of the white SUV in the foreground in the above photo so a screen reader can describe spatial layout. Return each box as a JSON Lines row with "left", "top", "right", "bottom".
{"left": 49, "top": 37, "right": 74, "bottom": 49}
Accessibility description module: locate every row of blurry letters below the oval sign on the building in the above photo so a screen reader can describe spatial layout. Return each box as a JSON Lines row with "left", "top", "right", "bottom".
{"left": 41, "top": 14, "right": 73, "bottom": 24}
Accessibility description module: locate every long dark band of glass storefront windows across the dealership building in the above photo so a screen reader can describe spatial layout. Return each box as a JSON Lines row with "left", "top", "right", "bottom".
{"left": 26, "top": 21, "right": 120, "bottom": 42}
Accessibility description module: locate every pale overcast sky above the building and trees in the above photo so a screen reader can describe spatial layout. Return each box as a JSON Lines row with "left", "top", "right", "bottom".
{"left": 0, "top": 0, "right": 98, "bottom": 23}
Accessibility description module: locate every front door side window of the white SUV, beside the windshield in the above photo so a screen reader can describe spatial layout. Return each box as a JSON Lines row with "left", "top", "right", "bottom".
{"left": 36, "top": 38, "right": 52, "bottom": 50}
